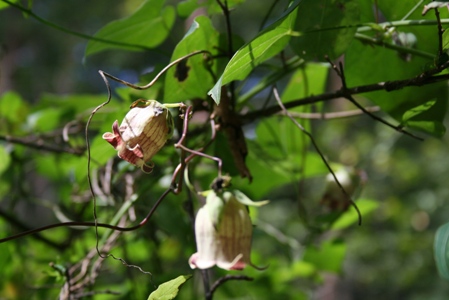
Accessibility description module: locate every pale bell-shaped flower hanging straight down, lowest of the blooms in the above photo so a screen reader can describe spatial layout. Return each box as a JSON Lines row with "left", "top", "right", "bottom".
{"left": 189, "top": 185, "right": 268, "bottom": 270}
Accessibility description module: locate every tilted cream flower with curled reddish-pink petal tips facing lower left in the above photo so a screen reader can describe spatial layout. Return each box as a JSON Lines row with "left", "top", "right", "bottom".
{"left": 103, "top": 100, "right": 174, "bottom": 173}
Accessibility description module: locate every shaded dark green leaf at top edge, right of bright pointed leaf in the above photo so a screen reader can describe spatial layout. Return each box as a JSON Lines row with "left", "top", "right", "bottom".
{"left": 290, "top": 0, "right": 360, "bottom": 60}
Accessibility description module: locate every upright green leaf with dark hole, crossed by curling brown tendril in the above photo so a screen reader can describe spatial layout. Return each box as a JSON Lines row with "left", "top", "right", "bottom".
{"left": 164, "top": 16, "right": 219, "bottom": 102}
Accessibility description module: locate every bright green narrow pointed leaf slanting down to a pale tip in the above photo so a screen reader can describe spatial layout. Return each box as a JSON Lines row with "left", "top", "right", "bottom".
{"left": 209, "top": 0, "right": 300, "bottom": 104}
